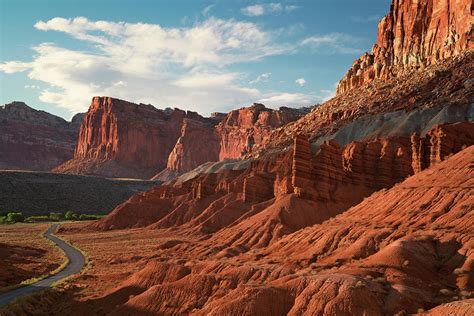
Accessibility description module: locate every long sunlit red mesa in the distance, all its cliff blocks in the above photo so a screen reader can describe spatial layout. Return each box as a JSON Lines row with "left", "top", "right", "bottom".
{"left": 54, "top": 97, "right": 305, "bottom": 181}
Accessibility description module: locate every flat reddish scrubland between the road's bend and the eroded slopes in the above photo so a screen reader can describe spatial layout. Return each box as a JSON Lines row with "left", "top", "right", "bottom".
{"left": 53, "top": 222, "right": 191, "bottom": 299}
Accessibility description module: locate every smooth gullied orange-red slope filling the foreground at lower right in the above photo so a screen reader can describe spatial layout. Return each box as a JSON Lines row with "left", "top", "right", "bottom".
{"left": 61, "top": 148, "right": 474, "bottom": 315}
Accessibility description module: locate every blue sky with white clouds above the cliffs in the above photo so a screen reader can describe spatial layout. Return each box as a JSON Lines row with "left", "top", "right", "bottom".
{"left": 0, "top": 0, "right": 390, "bottom": 119}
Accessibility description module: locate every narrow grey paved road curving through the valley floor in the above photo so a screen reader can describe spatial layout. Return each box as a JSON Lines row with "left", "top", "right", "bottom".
{"left": 0, "top": 224, "right": 85, "bottom": 305}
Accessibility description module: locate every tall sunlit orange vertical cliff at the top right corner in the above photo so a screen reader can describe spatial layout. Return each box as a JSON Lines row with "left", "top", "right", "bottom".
{"left": 337, "top": 0, "right": 473, "bottom": 94}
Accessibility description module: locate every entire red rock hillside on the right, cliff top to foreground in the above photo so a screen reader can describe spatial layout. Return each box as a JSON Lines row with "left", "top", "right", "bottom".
{"left": 16, "top": 0, "right": 474, "bottom": 315}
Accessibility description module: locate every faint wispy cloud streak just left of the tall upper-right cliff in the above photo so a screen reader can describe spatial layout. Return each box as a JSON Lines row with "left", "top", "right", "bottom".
{"left": 300, "top": 33, "right": 363, "bottom": 54}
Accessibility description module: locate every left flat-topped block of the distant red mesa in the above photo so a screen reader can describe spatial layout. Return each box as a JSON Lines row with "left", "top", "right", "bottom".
{"left": 55, "top": 97, "right": 187, "bottom": 178}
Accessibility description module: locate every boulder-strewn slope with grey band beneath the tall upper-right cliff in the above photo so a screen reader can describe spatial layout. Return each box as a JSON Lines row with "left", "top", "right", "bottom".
{"left": 252, "top": 51, "right": 474, "bottom": 156}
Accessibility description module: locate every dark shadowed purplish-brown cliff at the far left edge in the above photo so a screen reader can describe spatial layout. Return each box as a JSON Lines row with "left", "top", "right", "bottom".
{"left": 0, "top": 102, "right": 83, "bottom": 170}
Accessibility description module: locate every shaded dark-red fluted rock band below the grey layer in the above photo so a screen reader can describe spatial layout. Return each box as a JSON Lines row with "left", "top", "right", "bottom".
{"left": 94, "top": 123, "right": 474, "bottom": 232}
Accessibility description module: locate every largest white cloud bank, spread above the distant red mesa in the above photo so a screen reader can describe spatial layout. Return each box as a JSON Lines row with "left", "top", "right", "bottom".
{"left": 0, "top": 17, "right": 292, "bottom": 114}
